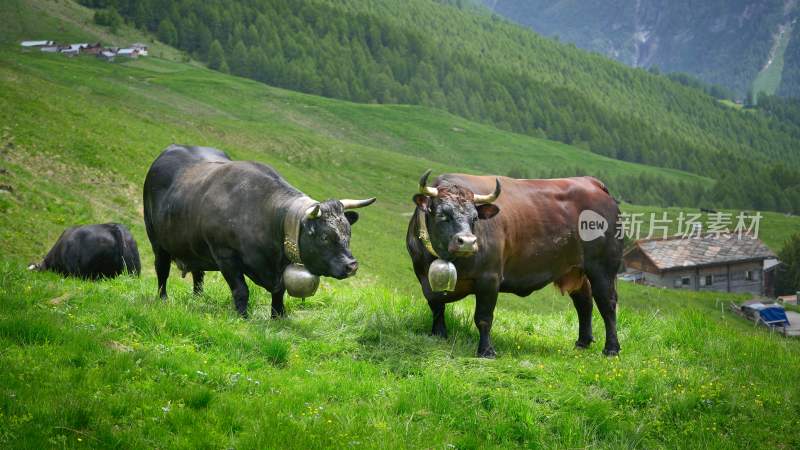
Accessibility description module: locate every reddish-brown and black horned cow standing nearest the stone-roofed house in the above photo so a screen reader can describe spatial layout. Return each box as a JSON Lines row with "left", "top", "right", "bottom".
{"left": 406, "top": 171, "right": 622, "bottom": 357}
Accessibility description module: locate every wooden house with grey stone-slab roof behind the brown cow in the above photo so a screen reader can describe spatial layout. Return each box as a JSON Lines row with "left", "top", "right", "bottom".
{"left": 624, "top": 235, "right": 776, "bottom": 295}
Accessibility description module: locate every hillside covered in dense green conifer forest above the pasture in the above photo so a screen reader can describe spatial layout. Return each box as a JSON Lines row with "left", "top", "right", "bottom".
{"left": 67, "top": 0, "right": 800, "bottom": 212}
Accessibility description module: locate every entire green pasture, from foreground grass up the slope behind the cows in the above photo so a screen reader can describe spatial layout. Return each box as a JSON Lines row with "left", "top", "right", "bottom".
{"left": 0, "top": 4, "right": 800, "bottom": 448}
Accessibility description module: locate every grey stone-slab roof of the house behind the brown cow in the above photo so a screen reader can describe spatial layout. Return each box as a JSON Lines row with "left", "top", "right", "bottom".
{"left": 625, "top": 234, "right": 775, "bottom": 270}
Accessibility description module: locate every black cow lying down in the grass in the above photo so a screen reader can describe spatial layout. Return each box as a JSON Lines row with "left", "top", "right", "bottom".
{"left": 28, "top": 223, "right": 142, "bottom": 279}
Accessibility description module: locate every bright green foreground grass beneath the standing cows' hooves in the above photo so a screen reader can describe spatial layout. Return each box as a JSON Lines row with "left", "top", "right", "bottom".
{"left": 0, "top": 264, "right": 800, "bottom": 448}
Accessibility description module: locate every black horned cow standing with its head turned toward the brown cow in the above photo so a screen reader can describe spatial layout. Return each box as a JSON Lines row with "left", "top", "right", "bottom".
{"left": 144, "top": 145, "right": 375, "bottom": 317}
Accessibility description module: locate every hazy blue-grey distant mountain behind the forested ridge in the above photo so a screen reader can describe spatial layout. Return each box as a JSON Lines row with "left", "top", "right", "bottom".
{"left": 483, "top": 0, "right": 800, "bottom": 98}
